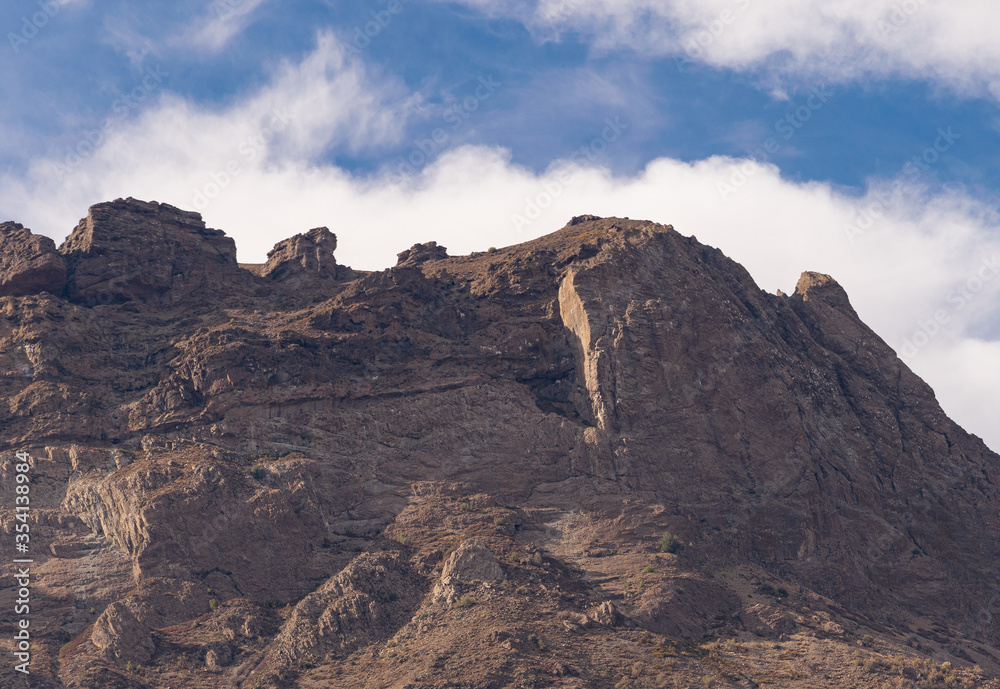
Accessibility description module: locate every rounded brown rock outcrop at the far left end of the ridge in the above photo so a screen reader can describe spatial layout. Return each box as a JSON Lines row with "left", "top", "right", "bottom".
{"left": 0, "top": 222, "right": 66, "bottom": 297}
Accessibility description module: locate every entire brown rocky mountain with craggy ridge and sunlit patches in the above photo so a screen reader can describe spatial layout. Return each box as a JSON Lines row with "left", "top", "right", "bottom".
{"left": 0, "top": 199, "right": 1000, "bottom": 689}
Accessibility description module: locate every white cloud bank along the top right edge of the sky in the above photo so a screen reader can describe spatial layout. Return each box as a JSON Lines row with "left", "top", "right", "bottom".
{"left": 438, "top": 0, "right": 1000, "bottom": 97}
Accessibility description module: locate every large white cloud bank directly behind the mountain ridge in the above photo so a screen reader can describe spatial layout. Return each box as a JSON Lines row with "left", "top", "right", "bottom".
{"left": 0, "top": 35, "right": 1000, "bottom": 449}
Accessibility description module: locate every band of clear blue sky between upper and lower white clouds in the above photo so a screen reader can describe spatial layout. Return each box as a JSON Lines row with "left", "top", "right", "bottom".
{"left": 7, "top": 0, "right": 1000, "bottom": 193}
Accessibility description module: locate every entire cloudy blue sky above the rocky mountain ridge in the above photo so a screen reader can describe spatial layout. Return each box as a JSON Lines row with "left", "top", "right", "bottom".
{"left": 0, "top": 0, "right": 1000, "bottom": 450}
